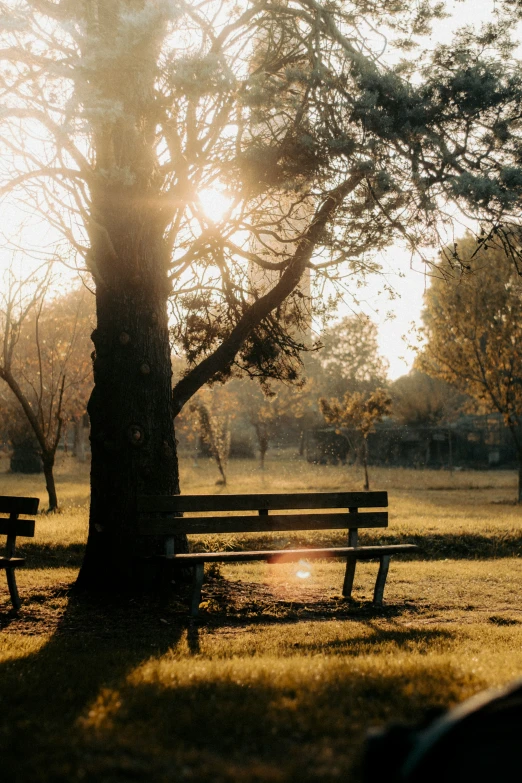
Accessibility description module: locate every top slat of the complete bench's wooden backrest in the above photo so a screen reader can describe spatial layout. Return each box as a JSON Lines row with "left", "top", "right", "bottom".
{"left": 138, "top": 491, "right": 388, "bottom": 514}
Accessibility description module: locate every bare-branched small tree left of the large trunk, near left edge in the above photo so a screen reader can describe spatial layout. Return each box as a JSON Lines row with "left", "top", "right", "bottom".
{"left": 0, "top": 270, "right": 93, "bottom": 511}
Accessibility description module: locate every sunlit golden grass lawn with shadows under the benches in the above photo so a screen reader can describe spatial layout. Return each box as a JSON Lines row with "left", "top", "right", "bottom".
{"left": 0, "top": 457, "right": 522, "bottom": 783}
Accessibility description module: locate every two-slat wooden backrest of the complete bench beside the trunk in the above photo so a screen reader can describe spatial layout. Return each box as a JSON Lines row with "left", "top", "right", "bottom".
{"left": 138, "top": 492, "right": 388, "bottom": 536}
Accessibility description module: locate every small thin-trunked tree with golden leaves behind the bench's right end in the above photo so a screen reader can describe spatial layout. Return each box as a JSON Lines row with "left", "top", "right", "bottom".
{"left": 319, "top": 389, "right": 391, "bottom": 490}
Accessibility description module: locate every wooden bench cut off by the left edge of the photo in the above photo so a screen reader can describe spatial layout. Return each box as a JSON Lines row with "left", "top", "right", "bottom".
{"left": 0, "top": 495, "right": 40, "bottom": 611}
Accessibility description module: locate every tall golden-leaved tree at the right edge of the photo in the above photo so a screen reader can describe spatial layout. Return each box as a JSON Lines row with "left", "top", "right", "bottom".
{"left": 418, "top": 236, "right": 522, "bottom": 502}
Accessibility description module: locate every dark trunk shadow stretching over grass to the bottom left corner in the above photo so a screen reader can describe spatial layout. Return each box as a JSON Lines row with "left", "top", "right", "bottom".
{"left": 0, "top": 597, "right": 186, "bottom": 783}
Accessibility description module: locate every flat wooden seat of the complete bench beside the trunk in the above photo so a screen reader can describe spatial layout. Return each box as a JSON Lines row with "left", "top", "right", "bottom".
{"left": 144, "top": 544, "right": 418, "bottom": 566}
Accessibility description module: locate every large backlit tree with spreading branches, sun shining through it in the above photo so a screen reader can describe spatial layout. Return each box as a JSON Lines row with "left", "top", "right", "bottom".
{"left": 0, "top": 0, "right": 520, "bottom": 588}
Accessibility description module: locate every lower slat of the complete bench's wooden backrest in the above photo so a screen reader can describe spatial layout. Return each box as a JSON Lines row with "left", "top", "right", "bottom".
{"left": 138, "top": 511, "right": 388, "bottom": 536}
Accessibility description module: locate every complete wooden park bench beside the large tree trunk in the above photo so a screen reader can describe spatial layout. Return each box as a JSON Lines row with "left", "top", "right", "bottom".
{"left": 138, "top": 492, "right": 417, "bottom": 617}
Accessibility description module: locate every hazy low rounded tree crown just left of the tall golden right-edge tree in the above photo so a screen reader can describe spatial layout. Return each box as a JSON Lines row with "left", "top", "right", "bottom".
{"left": 390, "top": 369, "right": 472, "bottom": 427}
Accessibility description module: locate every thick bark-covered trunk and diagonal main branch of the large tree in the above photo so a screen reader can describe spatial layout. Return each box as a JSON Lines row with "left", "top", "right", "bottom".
{"left": 69, "top": 13, "right": 365, "bottom": 594}
